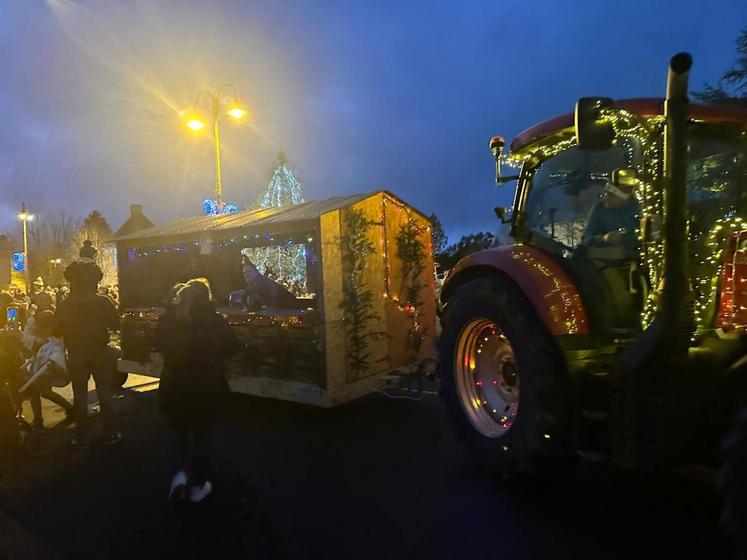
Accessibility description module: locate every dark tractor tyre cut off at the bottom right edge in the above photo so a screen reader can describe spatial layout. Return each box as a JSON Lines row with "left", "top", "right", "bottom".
{"left": 718, "top": 409, "right": 747, "bottom": 559}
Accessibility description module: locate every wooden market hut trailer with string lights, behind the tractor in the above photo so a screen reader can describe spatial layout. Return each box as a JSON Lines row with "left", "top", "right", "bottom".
{"left": 114, "top": 191, "right": 436, "bottom": 407}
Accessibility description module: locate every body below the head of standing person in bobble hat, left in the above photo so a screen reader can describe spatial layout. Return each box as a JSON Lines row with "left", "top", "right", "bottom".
{"left": 57, "top": 282, "right": 122, "bottom": 448}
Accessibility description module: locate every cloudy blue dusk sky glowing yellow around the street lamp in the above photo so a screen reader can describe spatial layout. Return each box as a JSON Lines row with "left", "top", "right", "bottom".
{"left": 0, "top": 0, "right": 747, "bottom": 241}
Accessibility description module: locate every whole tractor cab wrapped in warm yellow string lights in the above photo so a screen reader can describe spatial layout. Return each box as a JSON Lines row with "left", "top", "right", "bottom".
{"left": 498, "top": 99, "right": 747, "bottom": 338}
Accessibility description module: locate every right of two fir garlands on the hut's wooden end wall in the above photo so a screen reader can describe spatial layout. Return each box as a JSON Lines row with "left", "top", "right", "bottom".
{"left": 397, "top": 215, "right": 426, "bottom": 360}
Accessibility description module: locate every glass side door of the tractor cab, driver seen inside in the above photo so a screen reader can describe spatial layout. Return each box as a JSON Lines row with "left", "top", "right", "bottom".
{"left": 513, "top": 134, "right": 645, "bottom": 333}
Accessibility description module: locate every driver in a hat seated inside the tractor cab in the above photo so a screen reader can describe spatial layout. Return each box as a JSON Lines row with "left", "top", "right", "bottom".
{"left": 581, "top": 169, "right": 640, "bottom": 249}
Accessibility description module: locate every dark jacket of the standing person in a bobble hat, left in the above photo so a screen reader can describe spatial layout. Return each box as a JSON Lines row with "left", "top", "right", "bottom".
{"left": 55, "top": 293, "right": 119, "bottom": 352}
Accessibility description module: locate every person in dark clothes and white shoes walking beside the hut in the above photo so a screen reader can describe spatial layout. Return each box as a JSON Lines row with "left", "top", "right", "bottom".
{"left": 154, "top": 278, "right": 238, "bottom": 503}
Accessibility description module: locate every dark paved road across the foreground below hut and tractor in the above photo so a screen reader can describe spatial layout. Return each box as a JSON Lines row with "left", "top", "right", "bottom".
{"left": 0, "top": 378, "right": 730, "bottom": 560}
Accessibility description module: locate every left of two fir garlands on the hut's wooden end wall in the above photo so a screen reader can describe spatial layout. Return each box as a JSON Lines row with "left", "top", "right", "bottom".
{"left": 339, "top": 208, "right": 385, "bottom": 377}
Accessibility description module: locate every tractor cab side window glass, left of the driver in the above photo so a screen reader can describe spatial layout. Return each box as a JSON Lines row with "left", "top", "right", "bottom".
{"left": 524, "top": 137, "right": 641, "bottom": 248}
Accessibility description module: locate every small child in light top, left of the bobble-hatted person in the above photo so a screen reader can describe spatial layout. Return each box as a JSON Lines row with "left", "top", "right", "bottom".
{"left": 21, "top": 310, "right": 73, "bottom": 429}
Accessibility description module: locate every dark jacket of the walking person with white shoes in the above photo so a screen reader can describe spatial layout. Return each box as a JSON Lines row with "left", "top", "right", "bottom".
{"left": 153, "top": 304, "right": 239, "bottom": 417}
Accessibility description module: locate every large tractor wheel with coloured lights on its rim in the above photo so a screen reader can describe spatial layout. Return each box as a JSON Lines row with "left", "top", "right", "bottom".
{"left": 439, "top": 277, "right": 568, "bottom": 476}
